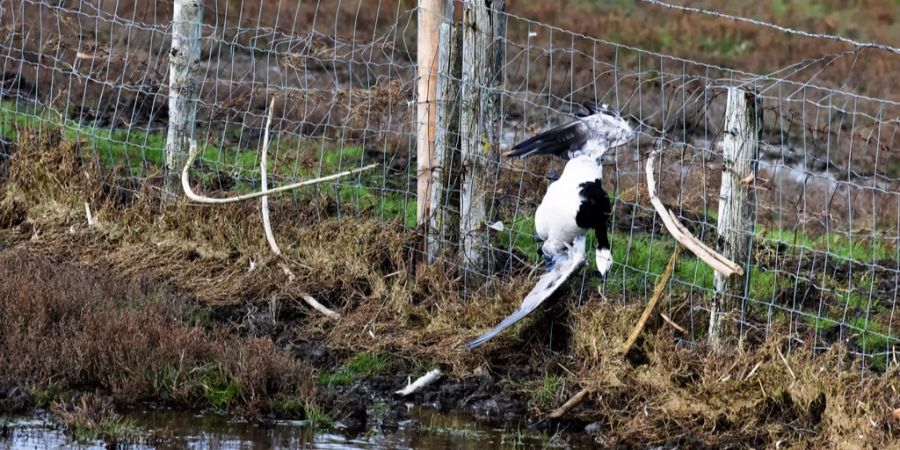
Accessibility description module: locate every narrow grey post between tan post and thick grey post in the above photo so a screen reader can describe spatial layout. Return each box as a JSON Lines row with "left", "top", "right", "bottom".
{"left": 427, "top": 0, "right": 462, "bottom": 262}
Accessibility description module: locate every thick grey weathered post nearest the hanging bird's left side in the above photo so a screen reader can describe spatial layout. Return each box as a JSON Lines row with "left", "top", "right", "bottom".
{"left": 459, "top": 0, "right": 505, "bottom": 278}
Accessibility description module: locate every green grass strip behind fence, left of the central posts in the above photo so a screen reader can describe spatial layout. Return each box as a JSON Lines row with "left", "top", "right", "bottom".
{"left": 0, "top": 101, "right": 416, "bottom": 227}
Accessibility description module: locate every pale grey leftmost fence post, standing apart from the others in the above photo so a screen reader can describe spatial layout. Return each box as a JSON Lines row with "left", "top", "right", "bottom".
{"left": 163, "top": 0, "right": 203, "bottom": 201}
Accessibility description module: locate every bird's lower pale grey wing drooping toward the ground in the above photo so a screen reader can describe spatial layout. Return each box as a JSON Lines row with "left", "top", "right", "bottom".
{"left": 466, "top": 236, "right": 585, "bottom": 350}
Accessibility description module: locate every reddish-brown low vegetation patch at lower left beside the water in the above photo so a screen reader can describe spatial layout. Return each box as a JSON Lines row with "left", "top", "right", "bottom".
{"left": 0, "top": 250, "right": 315, "bottom": 412}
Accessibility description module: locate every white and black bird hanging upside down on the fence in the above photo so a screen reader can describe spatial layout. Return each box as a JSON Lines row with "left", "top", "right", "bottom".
{"left": 466, "top": 102, "right": 634, "bottom": 349}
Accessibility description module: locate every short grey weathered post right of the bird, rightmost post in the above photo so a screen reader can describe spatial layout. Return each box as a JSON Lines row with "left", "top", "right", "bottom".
{"left": 709, "top": 87, "right": 761, "bottom": 347}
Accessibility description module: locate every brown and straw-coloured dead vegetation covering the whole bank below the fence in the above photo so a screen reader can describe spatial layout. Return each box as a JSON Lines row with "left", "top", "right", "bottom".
{"left": 0, "top": 126, "right": 900, "bottom": 448}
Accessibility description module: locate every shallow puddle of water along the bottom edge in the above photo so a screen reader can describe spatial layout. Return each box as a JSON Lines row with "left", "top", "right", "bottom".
{"left": 0, "top": 407, "right": 594, "bottom": 450}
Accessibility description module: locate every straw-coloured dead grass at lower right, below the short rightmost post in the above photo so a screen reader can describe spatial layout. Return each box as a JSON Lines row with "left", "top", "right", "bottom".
{"left": 567, "top": 303, "right": 900, "bottom": 448}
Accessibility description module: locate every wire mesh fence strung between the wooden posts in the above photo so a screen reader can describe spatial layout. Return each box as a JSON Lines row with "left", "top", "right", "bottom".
{"left": 0, "top": 0, "right": 900, "bottom": 368}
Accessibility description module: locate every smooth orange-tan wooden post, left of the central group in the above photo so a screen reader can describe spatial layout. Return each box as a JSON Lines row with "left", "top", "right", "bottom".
{"left": 416, "top": 0, "right": 449, "bottom": 239}
